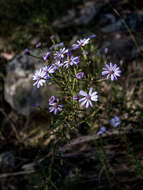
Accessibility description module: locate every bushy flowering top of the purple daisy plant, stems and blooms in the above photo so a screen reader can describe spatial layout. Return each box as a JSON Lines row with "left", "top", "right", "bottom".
{"left": 24, "top": 35, "right": 121, "bottom": 140}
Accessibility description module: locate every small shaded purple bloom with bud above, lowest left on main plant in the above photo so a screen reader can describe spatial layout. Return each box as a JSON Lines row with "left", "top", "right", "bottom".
{"left": 49, "top": 97, "right": 63, "bottom": 115}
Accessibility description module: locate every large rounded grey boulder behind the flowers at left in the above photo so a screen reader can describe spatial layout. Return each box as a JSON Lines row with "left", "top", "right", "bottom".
{"left": 4, "top": 49, "right": 55, "bottom": 116}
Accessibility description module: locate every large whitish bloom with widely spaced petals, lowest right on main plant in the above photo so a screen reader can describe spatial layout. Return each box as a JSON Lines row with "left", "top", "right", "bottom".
{"left": 79, "top": 87, "right": 98, "bottom": 108}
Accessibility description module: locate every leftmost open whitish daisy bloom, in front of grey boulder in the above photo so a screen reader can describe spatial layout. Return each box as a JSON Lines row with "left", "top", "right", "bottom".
{"left": 33, "top": 69, "right": 47, "bottom": 88}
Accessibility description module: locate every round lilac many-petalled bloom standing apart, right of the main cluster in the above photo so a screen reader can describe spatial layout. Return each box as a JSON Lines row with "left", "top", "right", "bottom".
{"left": 102, "top": 62, "right": 121, "bottom": 81}
